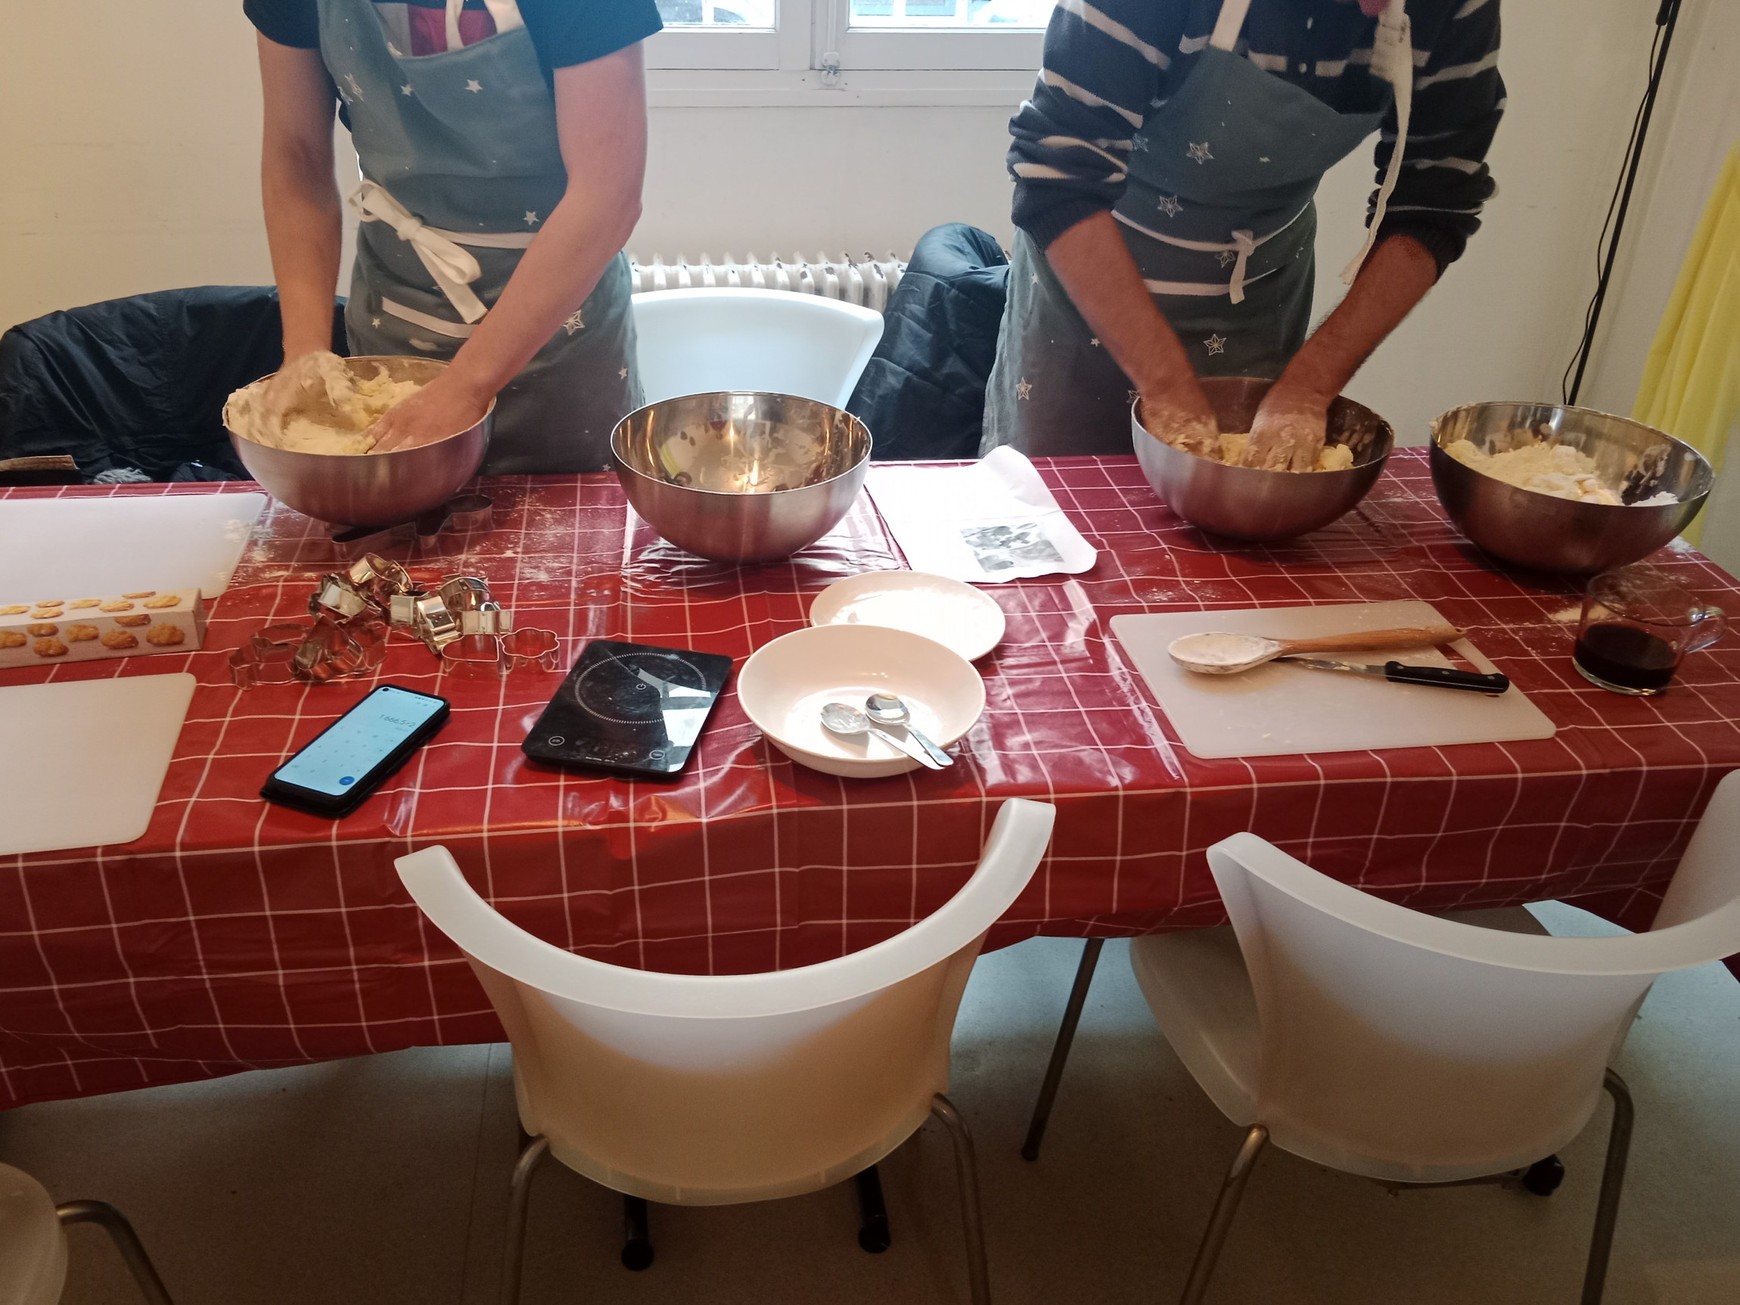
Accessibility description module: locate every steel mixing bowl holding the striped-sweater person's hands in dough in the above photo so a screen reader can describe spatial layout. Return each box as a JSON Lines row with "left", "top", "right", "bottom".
{"left": 1129, "top": 376, "right": 1395, "bottom": 543}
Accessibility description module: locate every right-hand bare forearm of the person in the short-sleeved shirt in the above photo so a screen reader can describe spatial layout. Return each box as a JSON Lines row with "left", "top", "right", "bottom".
{"left": 449, "top": 186, "right": 640, "bottom": 400}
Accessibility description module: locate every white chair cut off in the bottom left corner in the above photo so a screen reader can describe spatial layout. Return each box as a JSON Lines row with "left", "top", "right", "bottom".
{"left": 0, "top": 1164, "right": 172, "bottom": 1305}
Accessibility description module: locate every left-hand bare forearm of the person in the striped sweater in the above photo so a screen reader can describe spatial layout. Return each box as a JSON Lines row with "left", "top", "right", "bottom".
{"left": 1046, "top": 212, "right": 1206, "bottom": 409}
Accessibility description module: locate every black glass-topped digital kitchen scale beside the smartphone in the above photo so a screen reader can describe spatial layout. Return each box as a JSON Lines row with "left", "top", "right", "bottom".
{"left": 520, "top": 639, "right": 731, "bottom": 780}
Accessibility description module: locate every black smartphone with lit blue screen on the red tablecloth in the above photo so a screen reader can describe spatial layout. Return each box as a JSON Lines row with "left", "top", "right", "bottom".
{"left": 259, "top": 684, "right": 449, "bottom": 820}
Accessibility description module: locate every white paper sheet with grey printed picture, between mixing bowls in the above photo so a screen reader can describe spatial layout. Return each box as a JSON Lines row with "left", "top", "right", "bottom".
{"left": 867, "top": 447, "right": 1100, "bottom": 585}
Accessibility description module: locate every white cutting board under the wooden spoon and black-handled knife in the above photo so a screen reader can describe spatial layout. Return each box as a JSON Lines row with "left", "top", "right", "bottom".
{"left": 1112, "top": 602, "right": 1554, "bottom": 759}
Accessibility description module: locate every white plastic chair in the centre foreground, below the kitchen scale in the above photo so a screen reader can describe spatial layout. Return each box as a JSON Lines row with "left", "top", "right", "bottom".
{"left": 397, "top": 799, "right": 1054, "bottom": 1305}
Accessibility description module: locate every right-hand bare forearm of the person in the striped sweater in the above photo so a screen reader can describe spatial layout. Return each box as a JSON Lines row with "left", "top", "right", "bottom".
{"left": 1275, "top": 235, "right": 1437, "bottom": 407}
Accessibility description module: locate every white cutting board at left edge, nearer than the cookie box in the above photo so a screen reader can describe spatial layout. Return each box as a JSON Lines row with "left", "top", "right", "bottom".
{"left": 0, "top": 673, "right": 193, "bottom": 856}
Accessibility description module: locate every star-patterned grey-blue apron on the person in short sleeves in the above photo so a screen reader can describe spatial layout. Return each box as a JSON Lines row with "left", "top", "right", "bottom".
{"left": 318, "top": 0, "right": 640, "bottom": 475}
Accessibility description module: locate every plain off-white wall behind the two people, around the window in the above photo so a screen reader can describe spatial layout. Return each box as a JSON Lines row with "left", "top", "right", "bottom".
{"left": 0, "top": 0, "right": 1737, "bottom": 442}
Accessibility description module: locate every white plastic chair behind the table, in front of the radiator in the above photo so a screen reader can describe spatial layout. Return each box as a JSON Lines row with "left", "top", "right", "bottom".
{"left": 632, "top": 287, "right": 882, "bottom": 407}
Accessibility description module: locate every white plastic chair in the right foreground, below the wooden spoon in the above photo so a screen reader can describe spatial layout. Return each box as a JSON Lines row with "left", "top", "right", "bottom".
{"left": 1023, "top": 771, "right": 1740, "bottom": 1305}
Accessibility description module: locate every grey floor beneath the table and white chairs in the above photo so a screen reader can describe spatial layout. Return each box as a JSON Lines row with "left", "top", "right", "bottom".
{"left": 0, "top": 908, "right": 1740, "bottom": 1305}
